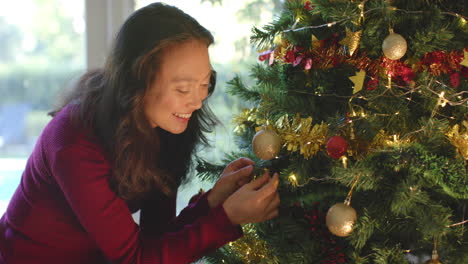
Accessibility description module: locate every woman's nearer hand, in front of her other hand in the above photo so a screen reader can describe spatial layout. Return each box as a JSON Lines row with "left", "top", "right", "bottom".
{"left": 223, "top": 171, "right": 280, "bottom": 225}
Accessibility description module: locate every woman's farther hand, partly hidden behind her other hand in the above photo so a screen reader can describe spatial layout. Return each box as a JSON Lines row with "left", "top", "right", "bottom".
{"left": 207, "top": 158, "right": 254, "bottom": 208}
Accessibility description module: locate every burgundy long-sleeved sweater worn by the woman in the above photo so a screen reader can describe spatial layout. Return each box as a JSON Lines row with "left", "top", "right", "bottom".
{"left": 0, "top": 106, "right": 242, "bottom": 264}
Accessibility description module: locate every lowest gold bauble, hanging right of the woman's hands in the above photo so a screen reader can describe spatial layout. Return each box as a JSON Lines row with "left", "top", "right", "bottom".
{"left": 326, "top": 203, "right": 357, "bottom": 237}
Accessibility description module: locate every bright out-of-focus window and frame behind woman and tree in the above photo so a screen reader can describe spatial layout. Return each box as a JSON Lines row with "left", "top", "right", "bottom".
{"left": 0, "top": 0, "right": 282, "bottom": 218}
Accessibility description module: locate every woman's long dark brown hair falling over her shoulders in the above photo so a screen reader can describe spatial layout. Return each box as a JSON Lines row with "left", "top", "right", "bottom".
{"left": 52, "top": 3, "right": 217, "bottom": 201}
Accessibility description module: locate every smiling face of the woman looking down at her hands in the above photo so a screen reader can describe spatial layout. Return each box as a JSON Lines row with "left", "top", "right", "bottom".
{"left": 144, "top": 40, "right": 211, "bottom": 134}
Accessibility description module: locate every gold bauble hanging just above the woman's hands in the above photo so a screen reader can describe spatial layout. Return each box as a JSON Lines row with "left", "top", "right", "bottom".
{"left": 252, "top": 129, "right": 281, "bottom": 160}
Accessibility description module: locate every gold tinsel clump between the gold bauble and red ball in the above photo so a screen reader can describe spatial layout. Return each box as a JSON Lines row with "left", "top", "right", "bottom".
{"left": 276, "top": 115, "right": 328, "bottom": 159}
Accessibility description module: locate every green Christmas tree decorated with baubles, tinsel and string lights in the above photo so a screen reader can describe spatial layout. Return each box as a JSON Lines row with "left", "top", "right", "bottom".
{"left": 198, "top": 0, "right": 468, "bottom": 264}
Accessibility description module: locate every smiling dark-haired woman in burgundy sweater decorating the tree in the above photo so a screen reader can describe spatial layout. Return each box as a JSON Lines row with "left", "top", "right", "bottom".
{"left": 0, "top": 3, "right": 279, "bottom": 264}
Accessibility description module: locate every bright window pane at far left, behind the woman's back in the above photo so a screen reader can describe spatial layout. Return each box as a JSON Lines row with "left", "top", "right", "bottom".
{"left": 0, "top": 0, "right": 85, "bottom": 215}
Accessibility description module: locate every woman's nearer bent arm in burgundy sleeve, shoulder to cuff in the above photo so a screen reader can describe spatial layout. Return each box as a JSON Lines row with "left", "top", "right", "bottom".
{"left": 50, "top": 145, "right": 241, "bottom": 264}
